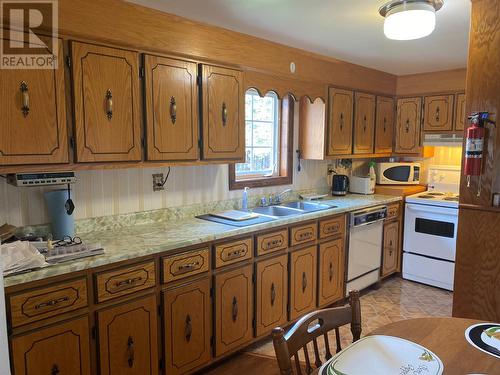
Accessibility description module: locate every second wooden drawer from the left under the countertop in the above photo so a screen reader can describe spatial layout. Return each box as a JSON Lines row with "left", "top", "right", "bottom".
{"left": 96, "top": 262, "right": 156, "bottom": 302}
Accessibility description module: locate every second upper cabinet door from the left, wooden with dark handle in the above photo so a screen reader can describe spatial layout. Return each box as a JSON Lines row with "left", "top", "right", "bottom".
{"left": 71, "top": 42, "right": 141, "bottom": 162}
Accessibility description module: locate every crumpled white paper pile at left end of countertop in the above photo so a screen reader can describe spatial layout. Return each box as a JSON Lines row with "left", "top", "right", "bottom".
{"left": 0, "top": 241, "right": 48, "bottom": 276}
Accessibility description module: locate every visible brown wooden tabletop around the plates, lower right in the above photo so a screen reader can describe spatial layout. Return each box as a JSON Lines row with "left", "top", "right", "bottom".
{"left": 325, "top": 318, "right": 500, "bottom": 375}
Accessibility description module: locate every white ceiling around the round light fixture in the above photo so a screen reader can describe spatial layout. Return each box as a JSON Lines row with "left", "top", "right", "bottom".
{"left": 129, "top": 0, "right": 471, "bottom": 75}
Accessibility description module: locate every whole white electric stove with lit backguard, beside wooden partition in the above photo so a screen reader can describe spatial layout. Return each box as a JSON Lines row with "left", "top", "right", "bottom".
{"left": 403, "top": 165, "right": 460, "bottom": 290}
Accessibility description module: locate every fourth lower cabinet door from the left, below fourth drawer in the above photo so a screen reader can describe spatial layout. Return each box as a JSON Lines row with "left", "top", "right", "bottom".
{"left": 215, "top": 265, "right": 253, "bottom": 356}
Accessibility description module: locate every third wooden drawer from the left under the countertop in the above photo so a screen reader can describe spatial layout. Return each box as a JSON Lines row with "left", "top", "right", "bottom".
{"left": 162, "top": 249, "right": 209, "bottom": 283}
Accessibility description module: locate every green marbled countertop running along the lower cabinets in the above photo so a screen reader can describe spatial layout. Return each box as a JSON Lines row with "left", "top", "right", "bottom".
{"left": 5, "top": 194, "right": 401, "bottom": 287}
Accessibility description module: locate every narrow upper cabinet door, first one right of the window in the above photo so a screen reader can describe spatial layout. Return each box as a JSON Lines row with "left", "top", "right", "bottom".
{"left": 327, "top": 88, "right": 353, "bottom": 156}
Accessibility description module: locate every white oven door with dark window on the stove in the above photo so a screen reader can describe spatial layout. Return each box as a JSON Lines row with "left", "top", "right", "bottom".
{"left": 403, "top": 203, "right": 458, "bottom": 262}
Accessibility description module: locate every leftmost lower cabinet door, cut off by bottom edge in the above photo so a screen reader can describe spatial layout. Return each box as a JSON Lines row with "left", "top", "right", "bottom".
{"left": 11, "top": 317, "right": 90, "bottom": 375}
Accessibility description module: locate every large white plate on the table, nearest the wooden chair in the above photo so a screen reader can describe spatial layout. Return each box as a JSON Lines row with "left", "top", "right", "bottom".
{"left": 320, "top": 335, "right": 444, "bottom": 375}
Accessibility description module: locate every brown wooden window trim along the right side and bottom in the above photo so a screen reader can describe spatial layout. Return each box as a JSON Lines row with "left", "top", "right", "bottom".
{"left": 229, "top": 95, "right": 295, "bottom": 190}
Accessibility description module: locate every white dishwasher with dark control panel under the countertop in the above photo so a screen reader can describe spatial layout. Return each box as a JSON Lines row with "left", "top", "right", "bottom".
{"left": 346, "top": 206, "right": 387, "bottom": 296}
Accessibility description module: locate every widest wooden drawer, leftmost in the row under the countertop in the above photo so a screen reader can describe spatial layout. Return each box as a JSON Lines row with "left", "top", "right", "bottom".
{"left": 9, "top": 279, "right": 88, "bottom": 327}
